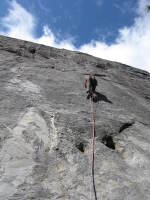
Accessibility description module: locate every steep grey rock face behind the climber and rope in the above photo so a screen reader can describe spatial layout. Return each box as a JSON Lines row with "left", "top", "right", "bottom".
{"left": 0, "top": 36, "right": 150, "bottom": 200}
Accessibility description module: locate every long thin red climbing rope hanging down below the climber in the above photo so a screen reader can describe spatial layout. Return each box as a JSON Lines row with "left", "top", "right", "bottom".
{"left": 91, "top": 92, "right": 97, "bottom": 200}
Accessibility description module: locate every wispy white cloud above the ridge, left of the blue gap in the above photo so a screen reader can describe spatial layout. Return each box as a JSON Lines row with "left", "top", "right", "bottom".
{"left": 0, "top": 0, "right": 75, "bottom": 50}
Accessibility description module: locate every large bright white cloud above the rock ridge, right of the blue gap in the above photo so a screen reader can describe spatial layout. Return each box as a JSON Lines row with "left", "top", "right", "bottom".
{"left": 80, "top": 8, "right": 150, "bottom": 71}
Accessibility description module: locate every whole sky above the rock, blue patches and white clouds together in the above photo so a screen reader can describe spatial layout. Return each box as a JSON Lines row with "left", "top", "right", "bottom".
{"left": 0, "top": 0, "right": 150, "bottom": 71}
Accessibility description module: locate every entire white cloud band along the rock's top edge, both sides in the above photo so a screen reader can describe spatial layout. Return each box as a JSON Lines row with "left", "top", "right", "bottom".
{"left": 0, "top": 0, "right": 150, "bottom": 72}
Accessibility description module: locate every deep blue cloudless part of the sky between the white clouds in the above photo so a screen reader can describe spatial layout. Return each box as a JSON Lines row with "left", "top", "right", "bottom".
{"left": 0, "top": 0, "right": 137, "bottom": 47}
